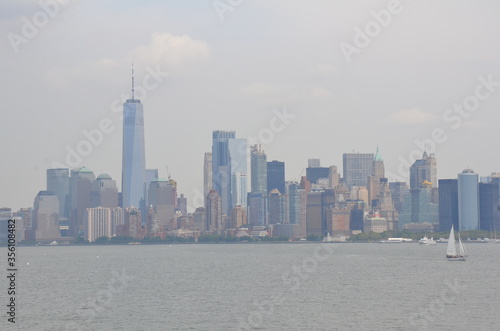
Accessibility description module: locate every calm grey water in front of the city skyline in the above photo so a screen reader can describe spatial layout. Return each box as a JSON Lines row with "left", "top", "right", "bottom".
{"left": 5, "top": 244, "right": 500, "bottom": 330}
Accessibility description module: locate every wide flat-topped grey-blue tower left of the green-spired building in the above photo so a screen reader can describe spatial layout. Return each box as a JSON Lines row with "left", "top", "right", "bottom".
{"left": 343, "top": 153, "right": 374, "bottom": 189}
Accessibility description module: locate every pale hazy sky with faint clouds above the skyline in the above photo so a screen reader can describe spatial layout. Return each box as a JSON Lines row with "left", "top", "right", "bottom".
{"left": 0, "top": 0, "right": 500, "bottom": 210}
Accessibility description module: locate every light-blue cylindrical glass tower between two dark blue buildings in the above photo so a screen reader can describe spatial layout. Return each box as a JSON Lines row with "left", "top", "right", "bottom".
{"left": 458, "top": 169, "right": 479, "bottom": 231}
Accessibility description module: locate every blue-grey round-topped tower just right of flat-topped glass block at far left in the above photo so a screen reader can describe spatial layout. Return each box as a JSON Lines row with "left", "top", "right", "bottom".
{"left": 68, "top": 167, "right": 95, "bottom": 236}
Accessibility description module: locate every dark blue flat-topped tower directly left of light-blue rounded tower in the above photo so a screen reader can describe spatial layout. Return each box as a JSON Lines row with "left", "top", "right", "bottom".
{"left": 439, "top": 179, "right": 459, "bottom": 232}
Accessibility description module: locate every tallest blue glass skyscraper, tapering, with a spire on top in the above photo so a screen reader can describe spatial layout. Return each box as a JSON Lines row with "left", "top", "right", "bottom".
{"left": 122, "top": 69, "right": 147, "bottom": 217}
